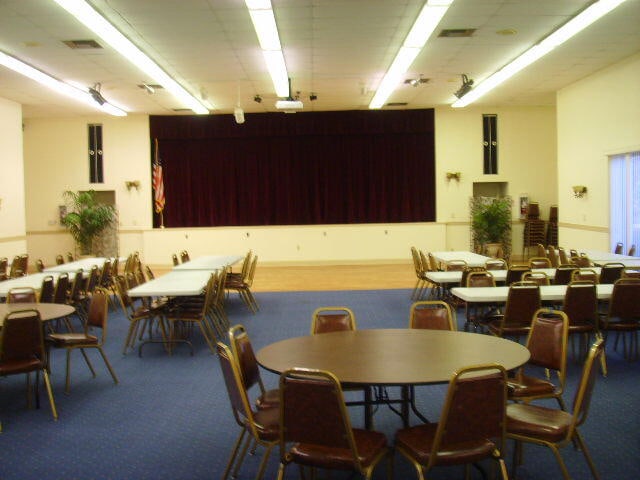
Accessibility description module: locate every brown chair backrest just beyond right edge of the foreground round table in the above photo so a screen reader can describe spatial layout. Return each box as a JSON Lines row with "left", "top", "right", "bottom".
{"left": 527, "top": 308, "right": 569, "bottom": 376}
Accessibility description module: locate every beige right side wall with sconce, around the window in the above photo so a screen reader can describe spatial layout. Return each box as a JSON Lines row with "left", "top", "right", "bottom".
{"left": 557, "top": 55, "right": 640, "bottom": 250}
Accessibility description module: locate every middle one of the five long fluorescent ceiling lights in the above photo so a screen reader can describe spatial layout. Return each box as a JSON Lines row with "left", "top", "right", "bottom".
{"left": 245, "top": 0, "right": 289, "bottom": 97}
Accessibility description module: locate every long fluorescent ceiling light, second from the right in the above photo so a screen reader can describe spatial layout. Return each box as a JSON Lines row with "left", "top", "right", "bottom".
{"left": 369, "top": 0, "right": 453, "bottom": 108}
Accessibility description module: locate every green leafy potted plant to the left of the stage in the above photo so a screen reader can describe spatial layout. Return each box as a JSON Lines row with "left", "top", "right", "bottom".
{"left": 61, "top": 190, "right": 115, "bottom": 255}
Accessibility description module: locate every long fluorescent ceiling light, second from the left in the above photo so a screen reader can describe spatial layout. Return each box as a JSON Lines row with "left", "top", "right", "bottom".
{"left": 54, "top": 0, "right": 213, "bottom": 115}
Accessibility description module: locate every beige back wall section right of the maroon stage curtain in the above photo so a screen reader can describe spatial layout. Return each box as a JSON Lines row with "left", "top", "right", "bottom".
{"left": 436, "top": 107, "right": 557, "bottom": 254}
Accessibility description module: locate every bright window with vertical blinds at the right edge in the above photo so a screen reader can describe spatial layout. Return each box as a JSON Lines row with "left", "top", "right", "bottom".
{"left": 609, "top": 152, "right": 640, "bottom": 253}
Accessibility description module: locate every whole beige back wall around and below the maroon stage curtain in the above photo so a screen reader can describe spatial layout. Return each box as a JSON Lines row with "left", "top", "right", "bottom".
{"left": 18, "top": 103, "right": 556, "bottom": 265}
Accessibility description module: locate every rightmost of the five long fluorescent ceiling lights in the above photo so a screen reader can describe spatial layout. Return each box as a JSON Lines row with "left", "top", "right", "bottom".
{"left": 451, "top": 0, "right": 626, "bottom": 108}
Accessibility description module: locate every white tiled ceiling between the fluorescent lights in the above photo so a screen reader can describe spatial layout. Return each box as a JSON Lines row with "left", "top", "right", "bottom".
{"left": 0, "top": 0, "right": 640, "bottom": 117}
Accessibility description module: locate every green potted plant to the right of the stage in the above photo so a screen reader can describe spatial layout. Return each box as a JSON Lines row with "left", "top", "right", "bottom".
{"left": 470, "top": 197, "right": 512, "bottom": 258}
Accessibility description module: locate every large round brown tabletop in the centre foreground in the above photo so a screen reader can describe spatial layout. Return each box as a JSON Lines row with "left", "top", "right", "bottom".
{"left": 257, "top": 329, "right": 529, "bottom": 385}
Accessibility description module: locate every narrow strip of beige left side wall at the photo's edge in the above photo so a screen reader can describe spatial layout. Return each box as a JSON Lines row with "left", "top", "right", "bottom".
{"left": 0, "top": 98, "right": 27, "bottom": 261}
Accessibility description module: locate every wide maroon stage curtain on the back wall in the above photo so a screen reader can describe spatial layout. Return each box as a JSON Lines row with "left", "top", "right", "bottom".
{"left": 150, "top": 109, "right": 435, "bottom": 227}
